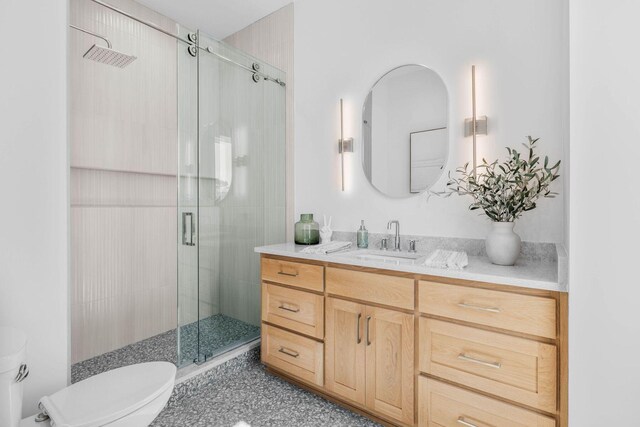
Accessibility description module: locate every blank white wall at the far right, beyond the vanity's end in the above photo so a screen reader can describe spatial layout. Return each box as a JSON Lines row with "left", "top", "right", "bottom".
{"left": 569, "top": 0, "right": 640, "bottom": 427}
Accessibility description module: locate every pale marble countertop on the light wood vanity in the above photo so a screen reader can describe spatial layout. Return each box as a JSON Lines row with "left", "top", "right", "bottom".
{"left": 255, "top": 243, "right": 568, "bottom": 292}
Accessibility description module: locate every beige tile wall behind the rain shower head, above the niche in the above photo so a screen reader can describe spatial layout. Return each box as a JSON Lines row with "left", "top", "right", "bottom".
{"left": 69, "top": 0, "right": 178, "bottom": 175}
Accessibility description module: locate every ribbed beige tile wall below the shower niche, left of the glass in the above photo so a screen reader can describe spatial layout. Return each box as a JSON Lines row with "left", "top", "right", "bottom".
{"left": 71, "top": 206, "right": 177, "bottom": 362}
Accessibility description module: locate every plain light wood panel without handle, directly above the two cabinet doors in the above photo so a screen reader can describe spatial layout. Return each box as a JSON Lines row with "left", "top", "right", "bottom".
{"left": 327, "top": 267, "right": 414, "bottom": 310}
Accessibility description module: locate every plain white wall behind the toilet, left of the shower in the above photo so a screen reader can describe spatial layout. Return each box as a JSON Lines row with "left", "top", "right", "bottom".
{"left": 0, "top": 0, "right": 69, "bottom": 414}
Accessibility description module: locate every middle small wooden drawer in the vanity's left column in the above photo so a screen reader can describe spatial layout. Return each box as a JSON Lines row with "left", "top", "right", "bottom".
{"left": 262, "top": 283, "right": 324, "bottom": 339}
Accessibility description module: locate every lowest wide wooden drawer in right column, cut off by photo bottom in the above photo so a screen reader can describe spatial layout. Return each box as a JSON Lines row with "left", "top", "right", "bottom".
{"left": 418, "top": 377, "right": 556, "bottom": 427}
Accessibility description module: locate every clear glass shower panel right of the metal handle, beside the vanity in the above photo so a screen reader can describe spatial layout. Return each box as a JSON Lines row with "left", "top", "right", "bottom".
{"left": 198, "top": 32, "right": 285, "bottom": 358}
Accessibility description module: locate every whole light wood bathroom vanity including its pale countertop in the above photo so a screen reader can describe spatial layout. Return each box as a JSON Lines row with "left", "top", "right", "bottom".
{"left": 256, "top": 244, "right": 568, "bottom": 427}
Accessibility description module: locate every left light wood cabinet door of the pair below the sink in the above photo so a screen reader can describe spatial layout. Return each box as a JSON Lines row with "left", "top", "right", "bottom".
{"left": 325, "top": 298, "right": 365, "bottom": 405}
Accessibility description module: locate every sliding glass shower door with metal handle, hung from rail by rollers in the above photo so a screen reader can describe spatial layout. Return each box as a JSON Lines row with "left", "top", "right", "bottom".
{"left": 178, "top": 28, "right": 286, "bottom": 366}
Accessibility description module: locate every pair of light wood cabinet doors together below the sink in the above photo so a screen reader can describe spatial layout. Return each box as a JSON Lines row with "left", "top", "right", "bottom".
{"left": 325, "top": 297, "right": 414, "bottom": 424}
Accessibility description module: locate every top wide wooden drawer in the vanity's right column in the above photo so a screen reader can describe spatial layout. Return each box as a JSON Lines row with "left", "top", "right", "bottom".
{"left": 418, "top": 281, "right": 556, "bottom": 338}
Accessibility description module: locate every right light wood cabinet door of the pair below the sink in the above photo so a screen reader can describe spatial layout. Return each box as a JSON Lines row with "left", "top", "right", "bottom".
{"left": 364, "top": 306, "right": 414, "bottom": 424}
